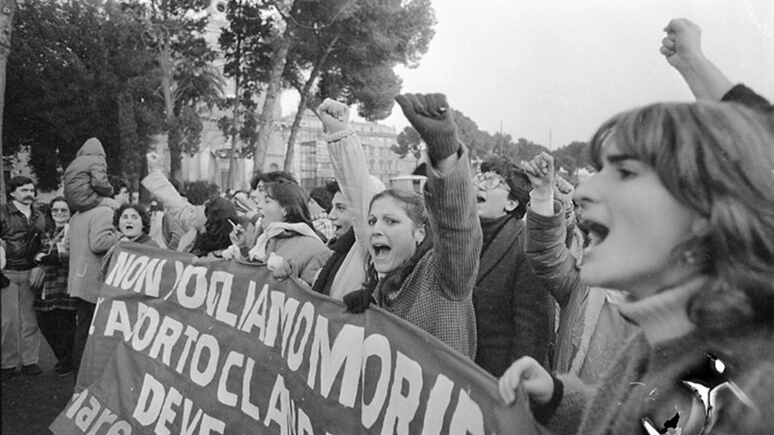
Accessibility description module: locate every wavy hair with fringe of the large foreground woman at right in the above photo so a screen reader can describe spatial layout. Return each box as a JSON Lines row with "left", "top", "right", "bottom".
{"left": 591, "top": 102, "right": 774, "bottom": 333}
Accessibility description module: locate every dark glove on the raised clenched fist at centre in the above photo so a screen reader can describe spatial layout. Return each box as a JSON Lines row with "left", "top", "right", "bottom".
{"left": 395, "top": 94, "right": 460, "bottom": 166}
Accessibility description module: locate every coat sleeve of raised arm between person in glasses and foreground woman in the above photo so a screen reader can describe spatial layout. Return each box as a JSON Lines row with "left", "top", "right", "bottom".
{"left": 524, "top": 206, "right": 582, "bottom": 309}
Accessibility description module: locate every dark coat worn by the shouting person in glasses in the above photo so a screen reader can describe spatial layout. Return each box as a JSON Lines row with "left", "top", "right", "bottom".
{"left": 473, "top": 218, "right": 555, "bottom": 377}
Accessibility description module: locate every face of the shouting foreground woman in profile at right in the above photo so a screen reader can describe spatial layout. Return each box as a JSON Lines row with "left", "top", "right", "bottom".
{"left": 575, "top": 143, "right": 701, "bottom": 299}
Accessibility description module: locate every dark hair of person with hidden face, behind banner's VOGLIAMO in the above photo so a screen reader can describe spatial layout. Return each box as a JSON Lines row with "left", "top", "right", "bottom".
{"left": 191, "top": 196, "right": 239, "bottom": 257}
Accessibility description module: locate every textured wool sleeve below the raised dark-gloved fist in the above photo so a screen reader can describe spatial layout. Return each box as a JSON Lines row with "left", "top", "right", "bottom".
{"left": 425, "top": 144, "right": 483, "bottom": 301}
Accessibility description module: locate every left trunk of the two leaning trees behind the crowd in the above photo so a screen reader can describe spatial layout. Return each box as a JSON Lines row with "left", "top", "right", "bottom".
{"left": 253, "top": 20, "right": 295, "bottom": 172}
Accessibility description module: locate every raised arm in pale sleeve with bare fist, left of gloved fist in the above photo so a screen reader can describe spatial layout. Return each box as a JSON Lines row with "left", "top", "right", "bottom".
{"left": 318, "top": 98, "right": 384, "bottom": 255}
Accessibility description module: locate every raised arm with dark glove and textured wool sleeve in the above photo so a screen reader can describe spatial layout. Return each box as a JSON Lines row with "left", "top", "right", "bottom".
{"left": 395, "top": 94, "right": 483, "bottom": 300}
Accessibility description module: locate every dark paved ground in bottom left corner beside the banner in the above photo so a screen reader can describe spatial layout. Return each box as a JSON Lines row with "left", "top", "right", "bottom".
{"left": 0, "top": 340, "right": 75, "bottom": 435}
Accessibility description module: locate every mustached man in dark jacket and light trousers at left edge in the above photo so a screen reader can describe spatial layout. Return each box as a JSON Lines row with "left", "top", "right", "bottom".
{"left": 0, "top": 176, "right": 46, "bottom": 380}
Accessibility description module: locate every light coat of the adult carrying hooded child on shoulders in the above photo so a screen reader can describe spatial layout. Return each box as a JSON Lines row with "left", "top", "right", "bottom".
{"left": 65, "top": 198, "right": 122, "bottom": 304}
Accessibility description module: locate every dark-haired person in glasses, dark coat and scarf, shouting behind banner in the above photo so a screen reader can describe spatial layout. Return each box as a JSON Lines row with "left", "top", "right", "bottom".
{"left": 473, "top": 157, "right": 555, "bottom": 376}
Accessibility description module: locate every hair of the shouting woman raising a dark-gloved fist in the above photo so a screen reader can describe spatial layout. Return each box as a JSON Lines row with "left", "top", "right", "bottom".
{"left": 363, "top": 189, "right": 433, "bottom": 302}
